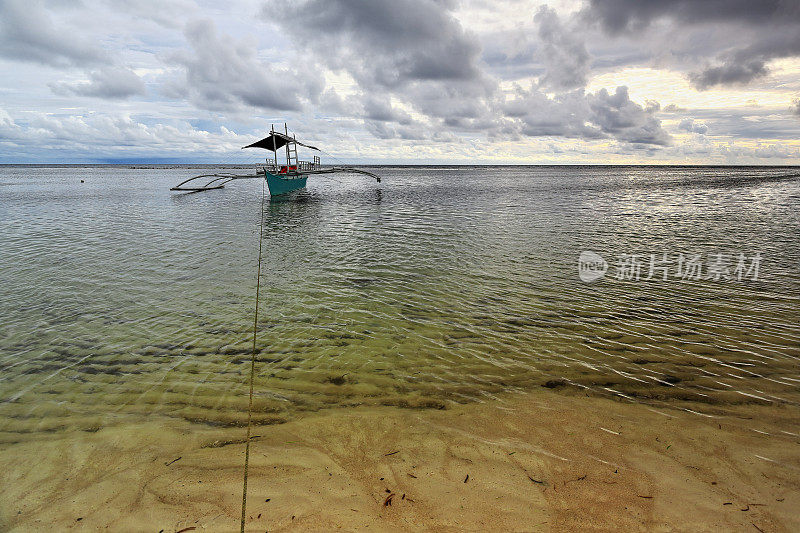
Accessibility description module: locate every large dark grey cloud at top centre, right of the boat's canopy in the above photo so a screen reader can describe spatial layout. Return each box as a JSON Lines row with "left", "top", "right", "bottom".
{"left": 262, "top": 0, "right": 496, "bottom": 132}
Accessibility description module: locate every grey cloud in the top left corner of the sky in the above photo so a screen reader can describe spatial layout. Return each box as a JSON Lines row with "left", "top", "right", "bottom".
{"left": 0, "top": 0, "right": 110, "bottom": 67}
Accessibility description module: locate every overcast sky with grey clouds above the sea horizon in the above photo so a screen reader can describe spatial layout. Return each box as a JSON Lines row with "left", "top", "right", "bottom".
{"left": 0, "top": 0, "right": 800, "bottom": 164}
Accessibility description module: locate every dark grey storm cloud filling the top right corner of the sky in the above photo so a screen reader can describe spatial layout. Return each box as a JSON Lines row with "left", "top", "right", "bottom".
{"left": 583, "top": 0, "right": 800, "bottom": 90}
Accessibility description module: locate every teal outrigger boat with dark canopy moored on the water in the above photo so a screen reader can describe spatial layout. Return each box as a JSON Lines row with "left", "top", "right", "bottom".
{"left": 170, "top": 124, "right": 381, "bottom": 196}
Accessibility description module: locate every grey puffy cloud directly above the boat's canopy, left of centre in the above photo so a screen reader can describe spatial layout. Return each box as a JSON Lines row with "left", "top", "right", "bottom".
{"left": 166, "top": 20, "right": 323, "bottom": 111}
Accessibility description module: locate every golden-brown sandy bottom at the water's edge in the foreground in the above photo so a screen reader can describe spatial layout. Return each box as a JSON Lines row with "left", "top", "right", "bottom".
{"left": 0, "top": 390, "right": 800, "bottom": 533}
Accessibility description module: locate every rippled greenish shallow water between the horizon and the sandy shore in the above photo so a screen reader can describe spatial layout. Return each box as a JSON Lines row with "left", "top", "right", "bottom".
{"left": 0, "top": 167, "right": 800, "bottom": 443}
